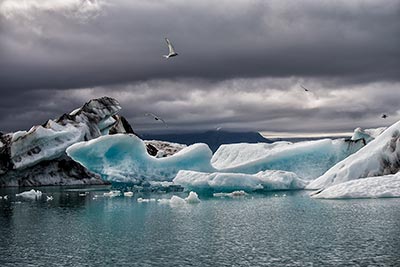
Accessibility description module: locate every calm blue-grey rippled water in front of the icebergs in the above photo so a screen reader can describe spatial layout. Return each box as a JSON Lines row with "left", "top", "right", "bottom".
{"left": 0, "top": 187, "right": 400, "bottom": 266}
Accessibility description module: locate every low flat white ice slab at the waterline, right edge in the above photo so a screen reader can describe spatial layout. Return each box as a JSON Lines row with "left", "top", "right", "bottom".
{"left": 311, "top": 174, "right": 400, "bottom": 199}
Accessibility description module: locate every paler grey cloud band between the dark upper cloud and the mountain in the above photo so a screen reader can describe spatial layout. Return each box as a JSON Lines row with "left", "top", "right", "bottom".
{"left": 0, "top": 78, "right": 400, "bottom": 133}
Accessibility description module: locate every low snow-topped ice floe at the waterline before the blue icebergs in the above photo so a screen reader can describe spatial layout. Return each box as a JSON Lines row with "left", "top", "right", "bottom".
{"left": 173, "top": 170, "right": 307, "bottom": 192}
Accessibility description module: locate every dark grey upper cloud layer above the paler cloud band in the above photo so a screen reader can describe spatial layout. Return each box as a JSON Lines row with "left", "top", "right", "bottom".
{"left": 0, "top": 0, "right": 400, "bottom": 90}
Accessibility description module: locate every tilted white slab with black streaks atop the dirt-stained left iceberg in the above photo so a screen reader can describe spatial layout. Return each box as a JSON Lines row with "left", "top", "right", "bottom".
{"left": 10, "top": 98, "right": 121, "bottom": 169}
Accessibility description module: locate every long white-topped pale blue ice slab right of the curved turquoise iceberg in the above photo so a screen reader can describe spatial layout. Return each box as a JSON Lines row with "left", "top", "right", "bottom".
{"left": 212, "top": 139, "right": 363, "bottom": 180}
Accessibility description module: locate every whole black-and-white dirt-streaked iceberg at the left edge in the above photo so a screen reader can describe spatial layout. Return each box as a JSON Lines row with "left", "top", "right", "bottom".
{"left": 0, "top": 97, "right": 147, "bottom": 186}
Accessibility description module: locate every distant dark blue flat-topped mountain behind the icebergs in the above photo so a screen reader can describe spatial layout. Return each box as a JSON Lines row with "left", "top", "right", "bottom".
{"left": 140, "top": 131, "right": 271, "bottom": 152}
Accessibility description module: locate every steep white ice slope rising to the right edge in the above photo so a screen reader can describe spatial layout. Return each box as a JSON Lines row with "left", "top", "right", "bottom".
{"left": 307, "top": 122, "right": 400, "bottom": 189}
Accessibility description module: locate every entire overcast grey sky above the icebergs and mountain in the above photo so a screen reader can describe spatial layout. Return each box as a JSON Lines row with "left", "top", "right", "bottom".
{"left": 0, "top": 0, "right": 400, "bottom": 136}
